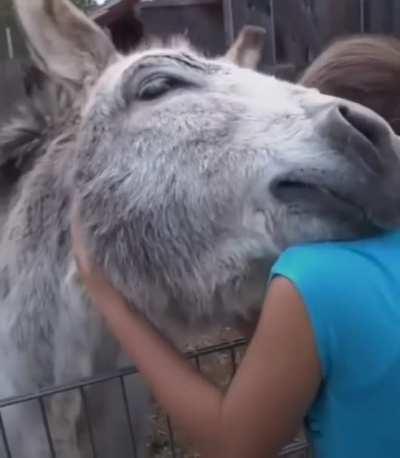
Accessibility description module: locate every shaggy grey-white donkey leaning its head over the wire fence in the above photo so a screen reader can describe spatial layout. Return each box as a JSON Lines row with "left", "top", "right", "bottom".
{"left": 0, "top": 0, "right": 400, "bottom": 458}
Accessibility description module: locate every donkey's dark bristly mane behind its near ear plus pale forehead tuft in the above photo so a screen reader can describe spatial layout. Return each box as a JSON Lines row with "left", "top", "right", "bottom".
{"left": 0, "top": 35, "right": 198, "bottom": 200}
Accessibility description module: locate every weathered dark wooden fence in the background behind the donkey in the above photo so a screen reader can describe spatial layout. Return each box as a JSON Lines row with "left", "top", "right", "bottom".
{"left": 0, "top": 0, "right": 400, "bottom": 122}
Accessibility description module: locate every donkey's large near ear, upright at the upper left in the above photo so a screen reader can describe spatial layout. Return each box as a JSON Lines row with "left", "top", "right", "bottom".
{"left": 14, "top": 0, "right": 116, "bottom": 85}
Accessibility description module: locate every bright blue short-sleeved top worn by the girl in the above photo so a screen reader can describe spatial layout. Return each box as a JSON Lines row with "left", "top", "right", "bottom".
{"left": 272, "top": 232, "right": 400, "bottom": 458}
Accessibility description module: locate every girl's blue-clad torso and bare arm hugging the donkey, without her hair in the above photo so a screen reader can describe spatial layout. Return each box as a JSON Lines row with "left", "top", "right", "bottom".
{"left": 73, "top": 215, "right": 400, "bottom": 458}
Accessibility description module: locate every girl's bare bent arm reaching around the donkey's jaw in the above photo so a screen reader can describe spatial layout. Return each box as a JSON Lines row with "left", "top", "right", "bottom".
{"left": 72, "top": 225, "right": 321, "bottom": 458}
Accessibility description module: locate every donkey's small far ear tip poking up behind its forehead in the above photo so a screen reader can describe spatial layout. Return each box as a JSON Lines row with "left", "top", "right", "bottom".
{"left": 225, "top": 25, "right": 267, "bottom": 70}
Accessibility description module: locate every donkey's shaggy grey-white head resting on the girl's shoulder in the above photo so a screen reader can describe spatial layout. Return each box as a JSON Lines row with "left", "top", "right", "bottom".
{"left": 11, "top": 0, "right": 400, "bottom": 326}
